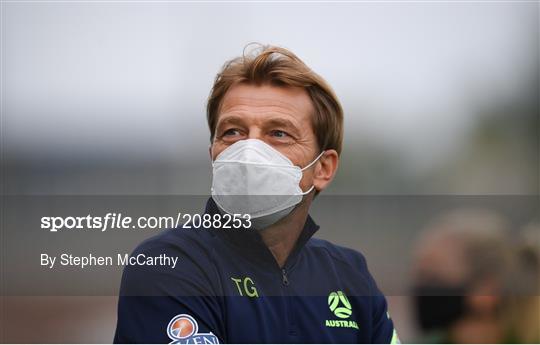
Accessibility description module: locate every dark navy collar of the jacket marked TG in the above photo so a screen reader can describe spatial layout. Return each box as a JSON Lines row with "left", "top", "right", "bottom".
{"left": 205, "top": 197, "right": 319, "bottom": 268}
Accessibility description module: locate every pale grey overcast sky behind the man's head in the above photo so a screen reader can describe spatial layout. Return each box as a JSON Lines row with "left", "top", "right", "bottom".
{"left": 2, "top": 2, "right": 538, "bottom": 164}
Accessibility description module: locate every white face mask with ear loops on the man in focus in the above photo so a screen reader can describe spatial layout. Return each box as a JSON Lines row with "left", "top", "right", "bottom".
{"left": 212, "top": 139, "right": 324, "bottom": 230}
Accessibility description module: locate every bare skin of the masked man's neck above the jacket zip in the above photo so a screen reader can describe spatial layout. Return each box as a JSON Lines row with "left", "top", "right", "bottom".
{"left": 261, "top": 195, "right": 313, "bottom": 267}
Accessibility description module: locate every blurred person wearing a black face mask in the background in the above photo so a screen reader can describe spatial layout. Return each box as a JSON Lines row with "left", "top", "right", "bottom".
{"left": 412, "top": 210, "right": 515, "bottom": 343}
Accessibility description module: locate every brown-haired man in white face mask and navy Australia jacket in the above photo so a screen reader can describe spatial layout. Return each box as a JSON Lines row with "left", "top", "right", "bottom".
{"left": 115, "top": 46, "right": 399, "bottom": 343}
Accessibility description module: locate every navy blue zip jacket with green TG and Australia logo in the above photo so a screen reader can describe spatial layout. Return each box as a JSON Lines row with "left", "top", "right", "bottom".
{"left": 114, "top": 199, "right": 398, "bottom": 344}
